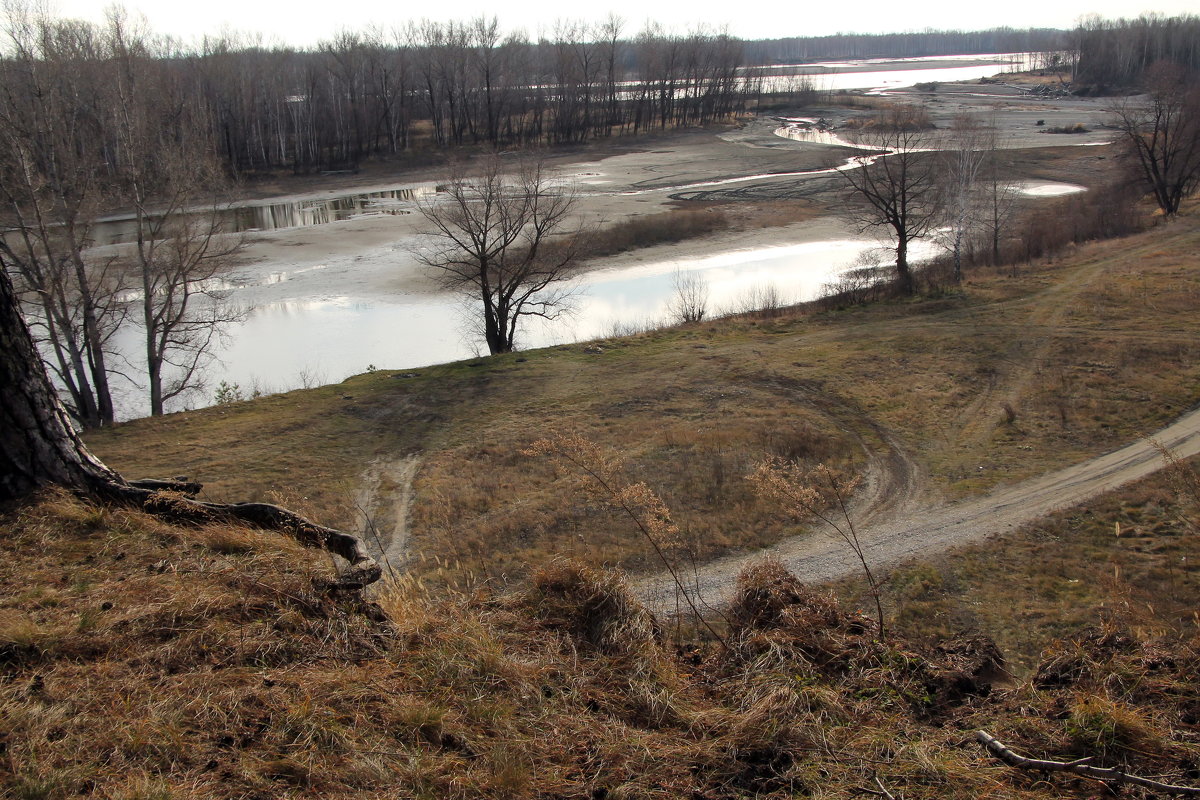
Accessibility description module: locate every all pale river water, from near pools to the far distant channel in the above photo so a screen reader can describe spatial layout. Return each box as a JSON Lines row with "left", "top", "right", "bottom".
{"left": 104, "top": 51, "right": 1080, "bottom": 417}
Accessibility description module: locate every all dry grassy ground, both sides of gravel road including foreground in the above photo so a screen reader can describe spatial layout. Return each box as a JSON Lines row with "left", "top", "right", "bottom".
{"left": 7, "top": 208, "right": 1200, "bottom": 800}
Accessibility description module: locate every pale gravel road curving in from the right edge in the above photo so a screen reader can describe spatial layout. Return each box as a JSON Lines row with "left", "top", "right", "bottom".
{"left": 636, "top": 409, "right": 1200, "bottom": 610}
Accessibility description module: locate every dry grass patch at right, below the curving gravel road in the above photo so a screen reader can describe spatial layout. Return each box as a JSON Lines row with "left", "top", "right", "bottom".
{"left": 883, "top": 459, "right": 1200, "bottom": 674}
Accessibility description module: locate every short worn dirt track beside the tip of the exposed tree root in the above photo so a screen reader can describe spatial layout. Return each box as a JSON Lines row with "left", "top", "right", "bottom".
{"left": 355, "top": 456, "right": 421, "bottom": 576}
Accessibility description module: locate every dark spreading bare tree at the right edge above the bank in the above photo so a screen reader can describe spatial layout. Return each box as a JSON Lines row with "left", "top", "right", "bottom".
{"left": 1111, "top": 61, "right": 1200, "bottom": 216}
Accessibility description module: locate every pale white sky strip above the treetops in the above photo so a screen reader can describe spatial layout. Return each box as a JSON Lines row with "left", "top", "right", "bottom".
{"left": 49, "top": 0, "right": 1195, "bottom": 46}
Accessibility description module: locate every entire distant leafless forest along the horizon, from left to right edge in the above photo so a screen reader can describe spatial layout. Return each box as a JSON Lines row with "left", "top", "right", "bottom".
{"left": 0, "top": 10, "right": 1200, "bottom": 181}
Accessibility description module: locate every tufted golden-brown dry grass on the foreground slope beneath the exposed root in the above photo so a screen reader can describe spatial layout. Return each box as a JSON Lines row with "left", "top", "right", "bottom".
{"left": 7, "top": 494, "right": 1200, "bottom": 800}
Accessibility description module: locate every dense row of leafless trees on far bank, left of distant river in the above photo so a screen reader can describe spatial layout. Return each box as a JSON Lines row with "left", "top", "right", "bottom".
{"left": 112, "top": 17, "right": 750, "bottom": 174}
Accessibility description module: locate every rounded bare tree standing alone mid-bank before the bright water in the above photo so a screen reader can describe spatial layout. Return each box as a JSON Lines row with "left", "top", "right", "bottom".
{"left": 418, "top": 156, "right": 580, "bottom": 355}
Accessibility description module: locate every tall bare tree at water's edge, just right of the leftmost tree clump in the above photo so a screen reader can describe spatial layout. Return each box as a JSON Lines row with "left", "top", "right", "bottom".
{"left": 106, "top": 13, "right": 242, "bottom": 416}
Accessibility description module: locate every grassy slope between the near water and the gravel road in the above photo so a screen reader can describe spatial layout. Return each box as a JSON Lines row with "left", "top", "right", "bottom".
{"left": 90, "top": 206, "right": 1200, "bottom": 578}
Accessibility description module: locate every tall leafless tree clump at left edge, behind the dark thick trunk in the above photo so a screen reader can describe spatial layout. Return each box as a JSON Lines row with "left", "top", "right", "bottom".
{"left": 0, "top": 5, "right": 122, "bottom": 427}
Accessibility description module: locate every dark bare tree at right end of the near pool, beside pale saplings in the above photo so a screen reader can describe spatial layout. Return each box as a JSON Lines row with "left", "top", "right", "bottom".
{"left": 841, "top": 112, "right": 941, "bottom": 294}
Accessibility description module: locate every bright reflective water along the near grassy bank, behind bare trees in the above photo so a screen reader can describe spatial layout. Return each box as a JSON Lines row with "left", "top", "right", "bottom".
{"left": 118, "top": 240, "right": 912, "bottom": 417}
